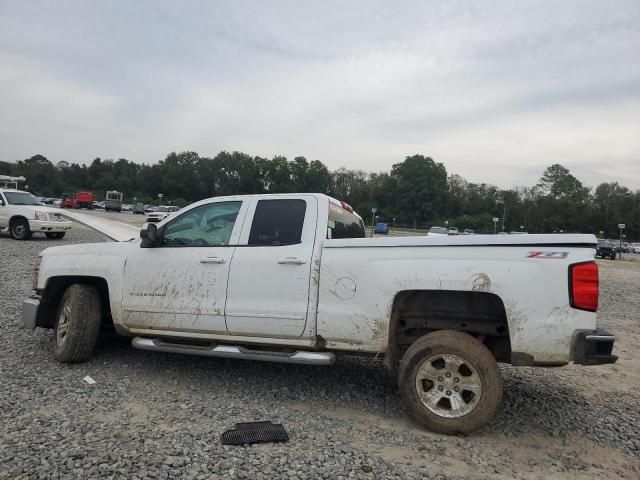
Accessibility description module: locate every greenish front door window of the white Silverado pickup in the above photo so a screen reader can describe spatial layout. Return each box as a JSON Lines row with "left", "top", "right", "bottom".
{"left": 162, "top": 202, "right": 242, "bottom": 247}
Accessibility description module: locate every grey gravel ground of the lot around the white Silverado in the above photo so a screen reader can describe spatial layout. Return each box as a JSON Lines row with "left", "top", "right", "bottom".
{"left": 0, "top": 227, "right": 640, "bottom": 480}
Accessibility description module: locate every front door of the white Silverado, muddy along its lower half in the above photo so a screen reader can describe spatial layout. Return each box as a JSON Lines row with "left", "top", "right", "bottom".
{"left": 122, "top": 200, "right": 248, "bottom": 334}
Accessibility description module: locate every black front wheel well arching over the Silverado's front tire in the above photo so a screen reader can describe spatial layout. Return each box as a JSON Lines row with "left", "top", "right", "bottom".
{"left": 36, "top": 276, "right": 112, "bottom": 328}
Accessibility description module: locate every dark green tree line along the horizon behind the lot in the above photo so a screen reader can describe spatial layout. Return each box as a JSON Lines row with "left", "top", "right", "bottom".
{"left": 0, "top": 151, "right": 640, "bottom": 240}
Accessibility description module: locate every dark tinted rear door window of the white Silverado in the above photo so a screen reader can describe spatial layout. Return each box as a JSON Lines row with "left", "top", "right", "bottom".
{"left": 249, "top": 199, "right": 307, "bottom": 246}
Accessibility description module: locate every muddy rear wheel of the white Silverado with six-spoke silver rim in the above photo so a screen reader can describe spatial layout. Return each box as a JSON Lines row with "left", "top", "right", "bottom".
{"left": 398, "top": 330, "right": 502, "bottom": 435}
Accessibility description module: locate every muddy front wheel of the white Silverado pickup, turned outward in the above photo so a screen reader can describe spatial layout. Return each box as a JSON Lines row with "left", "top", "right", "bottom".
{"left": 53, "top": 284, "right": 102, "bottom": 363}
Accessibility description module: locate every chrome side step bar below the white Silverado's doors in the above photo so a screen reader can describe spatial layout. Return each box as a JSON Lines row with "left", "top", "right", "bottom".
{"left": 131, "top": 337, "right": 336, "bottom": 365}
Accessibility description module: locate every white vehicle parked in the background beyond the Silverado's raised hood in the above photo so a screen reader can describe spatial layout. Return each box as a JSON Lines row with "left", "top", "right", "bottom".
{"left": 0, "top": 188, "right": 72, "bottom": 240}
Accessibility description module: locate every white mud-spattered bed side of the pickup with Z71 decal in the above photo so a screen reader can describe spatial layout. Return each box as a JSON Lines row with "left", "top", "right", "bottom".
{"left": 317, "top": 234, "right": 596, "bottom": 364}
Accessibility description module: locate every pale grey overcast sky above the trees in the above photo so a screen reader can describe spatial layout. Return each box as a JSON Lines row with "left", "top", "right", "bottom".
{"left": 0, "top": 0, "right": 640, "bottom": 189}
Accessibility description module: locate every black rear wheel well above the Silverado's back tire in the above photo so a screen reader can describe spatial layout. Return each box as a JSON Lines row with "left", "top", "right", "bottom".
{"left": 389, "top": 290, "right": 511, "bottom": 362}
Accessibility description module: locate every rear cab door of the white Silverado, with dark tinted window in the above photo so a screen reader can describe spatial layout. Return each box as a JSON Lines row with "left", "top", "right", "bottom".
{"left": 226, "top": 197, "right": 318, "bottom": 338}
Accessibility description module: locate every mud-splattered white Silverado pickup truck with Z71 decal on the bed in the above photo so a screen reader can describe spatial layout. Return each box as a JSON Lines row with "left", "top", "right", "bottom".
{"left": 23, "top": 194, "right": 617, "bottom": 433}
